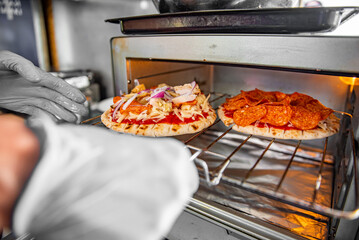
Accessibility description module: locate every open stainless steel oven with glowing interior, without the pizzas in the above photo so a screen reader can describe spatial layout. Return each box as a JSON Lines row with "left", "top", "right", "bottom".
{"left": 85, "top": 23, "right": 359, "bottom": 239}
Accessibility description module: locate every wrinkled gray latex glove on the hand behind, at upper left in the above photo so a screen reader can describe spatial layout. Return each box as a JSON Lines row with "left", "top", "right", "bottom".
{"left": 0, "top": 51, "right": 88, "bottom": 122}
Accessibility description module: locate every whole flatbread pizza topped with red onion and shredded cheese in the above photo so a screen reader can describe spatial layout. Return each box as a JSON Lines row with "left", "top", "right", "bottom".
{"left": 101, "top": 82, "right": 217, "bottom": 137}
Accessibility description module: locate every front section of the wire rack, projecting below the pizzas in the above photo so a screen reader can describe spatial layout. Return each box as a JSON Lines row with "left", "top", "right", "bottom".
{"left": 186, "top": 123, "right": 359, "bottom": 220}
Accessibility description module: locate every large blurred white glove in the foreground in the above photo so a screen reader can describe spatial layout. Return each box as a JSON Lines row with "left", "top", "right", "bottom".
{"left": 13, "top": 117, "right": 199, "bottom": 240}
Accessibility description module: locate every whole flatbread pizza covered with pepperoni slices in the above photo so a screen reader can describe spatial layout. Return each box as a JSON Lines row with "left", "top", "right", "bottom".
{"left": 218, "top": 89, "right": 340, "bottom": 139}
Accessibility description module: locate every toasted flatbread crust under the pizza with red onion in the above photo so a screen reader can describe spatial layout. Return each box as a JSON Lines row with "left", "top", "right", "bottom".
{"left": 101, "top": 109, "right": 217, "bottom": 137}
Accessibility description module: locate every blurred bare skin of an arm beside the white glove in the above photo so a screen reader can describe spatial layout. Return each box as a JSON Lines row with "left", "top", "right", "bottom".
{"left": 0, "top": 114, "right": 40, "bottom": 229}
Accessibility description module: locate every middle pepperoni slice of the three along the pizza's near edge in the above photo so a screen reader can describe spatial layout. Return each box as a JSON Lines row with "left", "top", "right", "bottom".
{"left": 261, "top": 105, "right": 292, "bottom": 126}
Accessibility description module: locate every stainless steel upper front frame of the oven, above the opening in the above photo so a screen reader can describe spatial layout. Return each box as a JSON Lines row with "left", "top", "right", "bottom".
{"left": 111, "top": 35, "right": 359, "bottom": 94}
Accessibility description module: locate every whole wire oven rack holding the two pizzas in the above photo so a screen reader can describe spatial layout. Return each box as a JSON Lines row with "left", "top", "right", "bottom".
{"left": 81, "top": 92, "right": 359, "bottom": 220}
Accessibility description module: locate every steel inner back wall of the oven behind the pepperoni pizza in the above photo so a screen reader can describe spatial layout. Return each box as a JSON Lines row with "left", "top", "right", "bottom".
{"left": 213, "top": 66, "right": 349, "bottom": 111}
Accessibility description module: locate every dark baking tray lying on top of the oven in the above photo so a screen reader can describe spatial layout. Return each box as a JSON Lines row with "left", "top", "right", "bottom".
{"left": 105, "top": 7, "right": 359, "bottom": 34}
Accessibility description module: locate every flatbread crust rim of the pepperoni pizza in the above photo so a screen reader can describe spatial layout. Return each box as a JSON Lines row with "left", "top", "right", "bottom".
{"left": 218, "top": 106, "right": 340, "bottom": 140}
